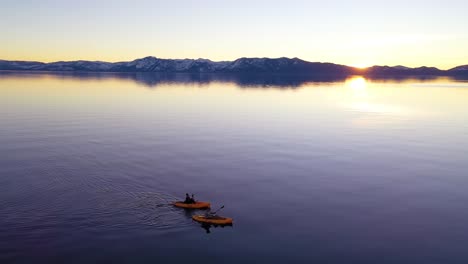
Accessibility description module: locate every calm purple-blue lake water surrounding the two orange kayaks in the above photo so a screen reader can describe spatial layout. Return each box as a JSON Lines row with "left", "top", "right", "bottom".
{"left": 0, "top": 72, "right": 468, "bottom": 264}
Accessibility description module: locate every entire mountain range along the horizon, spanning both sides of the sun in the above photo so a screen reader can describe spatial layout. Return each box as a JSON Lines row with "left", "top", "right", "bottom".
{"left": 0, "top": 56, "right": 468, "bottom": 76}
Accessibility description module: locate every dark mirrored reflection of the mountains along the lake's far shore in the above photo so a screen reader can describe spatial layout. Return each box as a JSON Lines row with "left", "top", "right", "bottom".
{"left": 0, "top": 71, "right": 466, "bottom": 88}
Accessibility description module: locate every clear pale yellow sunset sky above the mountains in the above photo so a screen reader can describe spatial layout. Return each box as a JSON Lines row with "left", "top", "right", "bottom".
{"left": 0, "top": 0, "right": 468, "bottom": 69}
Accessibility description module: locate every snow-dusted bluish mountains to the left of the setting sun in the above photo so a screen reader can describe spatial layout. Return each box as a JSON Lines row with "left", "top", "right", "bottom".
{"left": 0, "top": 57, "right": 352, "bottom": 74}
